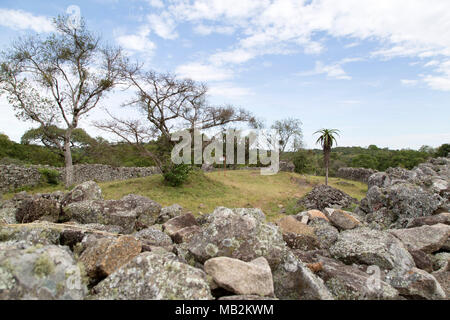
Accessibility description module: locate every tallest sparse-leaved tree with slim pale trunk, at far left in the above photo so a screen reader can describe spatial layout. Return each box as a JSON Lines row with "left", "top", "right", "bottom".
{"left": 0, "top": 16, "right": 126, "bottom": 186}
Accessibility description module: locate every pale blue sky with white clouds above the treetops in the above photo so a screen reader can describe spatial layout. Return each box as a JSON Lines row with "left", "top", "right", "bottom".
{"left": 0, "top": 0, "right": 450, "bottom": 149}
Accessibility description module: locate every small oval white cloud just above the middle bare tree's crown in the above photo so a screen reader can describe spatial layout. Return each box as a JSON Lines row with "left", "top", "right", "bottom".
{"left": 175, "top": 62, "right": 233, "bottom": 81}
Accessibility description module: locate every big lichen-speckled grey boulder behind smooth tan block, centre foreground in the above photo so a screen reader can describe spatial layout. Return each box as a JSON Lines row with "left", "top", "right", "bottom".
{"left": 185, "top": 207, "right": 286, "bottom": 267}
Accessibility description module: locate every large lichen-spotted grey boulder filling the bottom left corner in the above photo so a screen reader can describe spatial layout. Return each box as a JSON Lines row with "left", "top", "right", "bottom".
{"left": 0, "top": 241, "right": 87, "bottom": 300}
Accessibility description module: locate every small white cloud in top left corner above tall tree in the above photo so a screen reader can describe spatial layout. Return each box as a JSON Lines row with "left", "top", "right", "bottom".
{"left": 0, "top": 9, "right": 55, "bottom": 32}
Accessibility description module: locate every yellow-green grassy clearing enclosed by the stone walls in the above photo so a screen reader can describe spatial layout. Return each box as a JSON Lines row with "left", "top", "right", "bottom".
{"left": 5, "top": 170, "right": 367, "bottom": 220}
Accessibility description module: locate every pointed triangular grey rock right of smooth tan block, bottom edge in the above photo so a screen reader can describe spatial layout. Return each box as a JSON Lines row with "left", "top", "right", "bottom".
{"left": 272, "top": 250, "right": 334, "bottom": 300}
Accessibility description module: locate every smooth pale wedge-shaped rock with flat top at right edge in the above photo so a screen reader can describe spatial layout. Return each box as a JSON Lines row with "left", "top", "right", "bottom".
{"left": 389, "top": 224, "right": 450, "bottom": 253}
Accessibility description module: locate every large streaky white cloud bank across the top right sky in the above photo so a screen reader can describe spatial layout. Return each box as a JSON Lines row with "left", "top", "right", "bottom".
{"left": 156, "top": 0, "right": 450, "bottom": 89}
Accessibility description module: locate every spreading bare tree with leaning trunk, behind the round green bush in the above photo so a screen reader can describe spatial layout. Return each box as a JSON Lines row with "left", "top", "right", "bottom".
{"left": 95, "top": 70, "right": 253, "bottom": 169}
